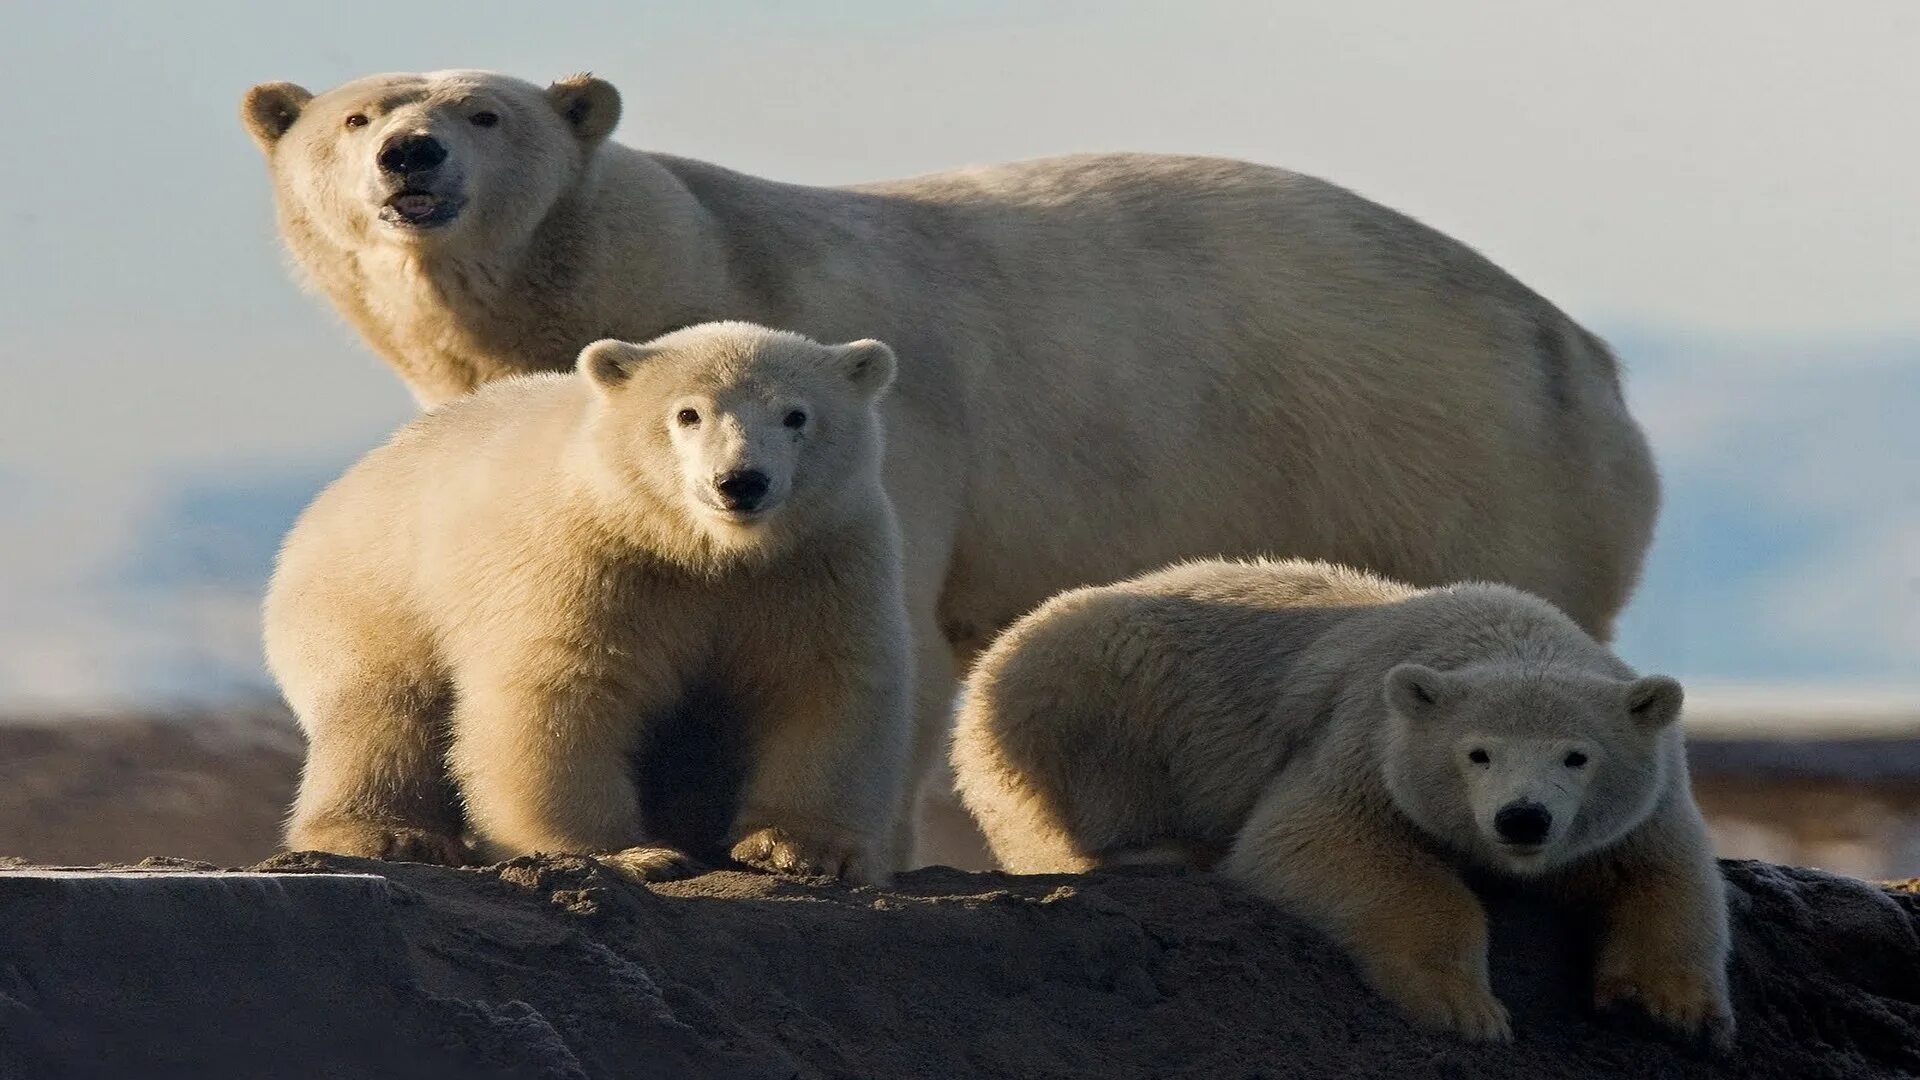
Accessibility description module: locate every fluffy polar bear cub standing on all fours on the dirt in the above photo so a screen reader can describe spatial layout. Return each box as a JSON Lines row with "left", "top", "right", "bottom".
{"left": 265, "top": 323, "right": 910, "bottom": 878}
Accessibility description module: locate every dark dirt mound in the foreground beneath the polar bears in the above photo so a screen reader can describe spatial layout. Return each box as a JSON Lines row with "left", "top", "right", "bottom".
{"left": 0, "top": 855, "right": 1920, "bottom": 1080}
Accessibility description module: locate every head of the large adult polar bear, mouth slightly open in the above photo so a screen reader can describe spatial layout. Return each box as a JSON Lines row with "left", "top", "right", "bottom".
{"left": 240, "top": 71, "right": 620, "bottom": 254}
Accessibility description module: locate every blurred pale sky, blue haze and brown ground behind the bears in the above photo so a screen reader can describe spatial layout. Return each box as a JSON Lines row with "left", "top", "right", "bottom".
{"left": 0, "top": 0, "right": 1920, "bottom": 876}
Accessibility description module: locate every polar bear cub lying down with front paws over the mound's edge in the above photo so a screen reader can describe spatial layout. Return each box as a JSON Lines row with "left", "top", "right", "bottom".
{"left": 952, "top": 561, "right": 1732, "bottom": 1040}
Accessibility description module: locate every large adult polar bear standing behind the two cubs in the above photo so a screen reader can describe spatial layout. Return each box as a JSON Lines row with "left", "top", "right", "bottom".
{"left": 242, "top": 71, "right": 1659, "bottom": 861}
